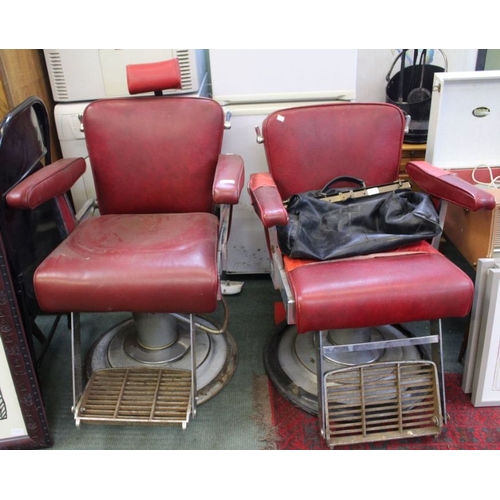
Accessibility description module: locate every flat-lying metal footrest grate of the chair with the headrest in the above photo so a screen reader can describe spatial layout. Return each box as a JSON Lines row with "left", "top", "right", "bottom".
{"left": 75, "top": 368, "right": 192, "bottom": 428}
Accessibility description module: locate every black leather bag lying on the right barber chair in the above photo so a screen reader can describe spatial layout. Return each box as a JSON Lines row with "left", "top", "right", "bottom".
{"left": 277, "top": 177, "right": 441, "bottom": 260}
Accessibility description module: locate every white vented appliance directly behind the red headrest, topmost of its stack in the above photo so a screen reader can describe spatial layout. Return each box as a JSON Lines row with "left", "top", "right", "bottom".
{"left": 43, "top": 49, "right": 208, "bottom": 102}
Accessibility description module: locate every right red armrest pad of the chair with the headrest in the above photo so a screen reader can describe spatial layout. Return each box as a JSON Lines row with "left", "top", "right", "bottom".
{"left": 213, "top": 154, "right": 245, "bottom": 205}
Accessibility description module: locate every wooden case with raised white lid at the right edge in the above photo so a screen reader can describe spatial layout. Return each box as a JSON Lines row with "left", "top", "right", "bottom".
{"left": 425, "top": 71, "right": 500, "bottom": 267}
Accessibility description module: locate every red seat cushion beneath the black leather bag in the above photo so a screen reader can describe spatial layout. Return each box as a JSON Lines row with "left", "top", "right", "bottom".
{"left": 285, "top": 242, "right": 474, "bottom": 333}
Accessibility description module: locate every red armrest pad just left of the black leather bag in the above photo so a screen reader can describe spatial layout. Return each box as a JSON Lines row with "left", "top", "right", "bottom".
{"left": 248, "top": 172, "right": 288, "bottom": 228}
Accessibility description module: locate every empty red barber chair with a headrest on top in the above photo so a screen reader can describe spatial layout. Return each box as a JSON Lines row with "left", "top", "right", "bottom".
{"left": 7, "top": 64, "right": 244, "bottom": 427}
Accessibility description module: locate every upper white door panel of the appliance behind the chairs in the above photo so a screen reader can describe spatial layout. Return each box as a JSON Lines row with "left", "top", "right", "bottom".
{"left": 209, "top": 49, "right": 357, "bottom": 104}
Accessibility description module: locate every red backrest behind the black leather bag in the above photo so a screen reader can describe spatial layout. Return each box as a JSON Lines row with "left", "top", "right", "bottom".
{"left": 262, "top": 103, "right": 405, "bottom": 199}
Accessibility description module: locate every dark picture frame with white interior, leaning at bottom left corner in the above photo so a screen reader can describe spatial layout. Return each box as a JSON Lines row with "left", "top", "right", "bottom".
{"left": 0, "top": 235, "right": 53, "bottom": 449}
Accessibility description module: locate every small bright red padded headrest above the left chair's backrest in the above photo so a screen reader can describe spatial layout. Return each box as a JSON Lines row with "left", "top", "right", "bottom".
{"left": 126, "top": 59, "right": 182, "bottom": 94}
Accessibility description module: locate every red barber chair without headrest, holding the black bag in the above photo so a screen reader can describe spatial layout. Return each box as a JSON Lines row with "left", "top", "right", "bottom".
{"left": 248, "top": 103, "right": 494, "bottom": 448}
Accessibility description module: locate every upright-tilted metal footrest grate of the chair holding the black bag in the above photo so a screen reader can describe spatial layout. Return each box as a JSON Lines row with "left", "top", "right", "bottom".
{"left": 323, "top": 361, "right": 443, "bottom": 448}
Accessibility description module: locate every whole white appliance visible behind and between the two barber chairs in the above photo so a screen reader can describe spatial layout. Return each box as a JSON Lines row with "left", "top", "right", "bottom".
{"left": 209, "top": 49, "right": 357, "bottom": 274}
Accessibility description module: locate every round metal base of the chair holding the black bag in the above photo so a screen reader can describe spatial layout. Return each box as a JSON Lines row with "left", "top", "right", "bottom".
{"left": 264, "top": 324, "right": 422, "bottom": 415}
